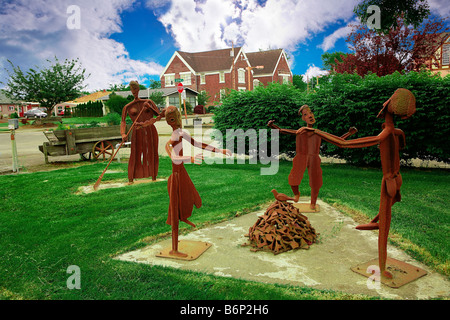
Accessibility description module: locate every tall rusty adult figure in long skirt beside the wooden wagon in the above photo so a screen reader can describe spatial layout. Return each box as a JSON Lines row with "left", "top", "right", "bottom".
{"left": 120, "top": 81, "right": 164, "bottom": 183}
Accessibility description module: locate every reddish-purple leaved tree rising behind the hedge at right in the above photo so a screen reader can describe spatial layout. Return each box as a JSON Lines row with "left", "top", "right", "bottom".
{"left": 335, "top": 16, "right": 448, "bottom": 76}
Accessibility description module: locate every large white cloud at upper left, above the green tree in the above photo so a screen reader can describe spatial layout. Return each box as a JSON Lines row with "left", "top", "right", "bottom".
{"left": 0, "top": 0, "right": 163, "bottom": 90}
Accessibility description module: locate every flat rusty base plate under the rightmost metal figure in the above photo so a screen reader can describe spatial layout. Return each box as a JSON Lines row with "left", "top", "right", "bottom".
{"left": 351, "top": 258, "right": 427, "bottom": 288}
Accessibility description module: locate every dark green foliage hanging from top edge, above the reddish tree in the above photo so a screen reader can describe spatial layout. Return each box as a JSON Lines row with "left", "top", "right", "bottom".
{"left": 353, "top": 0, "right": 430, "bottom": 33}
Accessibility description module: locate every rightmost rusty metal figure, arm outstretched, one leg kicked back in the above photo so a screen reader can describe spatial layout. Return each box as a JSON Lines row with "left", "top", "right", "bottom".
{"left": 299, "top": 88, "right": 416, "bottom": 279}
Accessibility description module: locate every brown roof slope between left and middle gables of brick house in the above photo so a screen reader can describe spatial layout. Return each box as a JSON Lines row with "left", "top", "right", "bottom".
{"left": 177, "top": 47, "right": 241, "bottom": 72}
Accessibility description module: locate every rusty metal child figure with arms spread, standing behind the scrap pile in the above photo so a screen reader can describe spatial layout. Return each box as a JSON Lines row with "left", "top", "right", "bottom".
{"left": 267, "top": 105, "right": 357, "bottom": 210}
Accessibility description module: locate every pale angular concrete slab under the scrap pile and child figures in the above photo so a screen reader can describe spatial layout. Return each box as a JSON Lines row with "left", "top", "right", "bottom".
{"left": 116, "top": 198, "right": 450, "bottom": 300}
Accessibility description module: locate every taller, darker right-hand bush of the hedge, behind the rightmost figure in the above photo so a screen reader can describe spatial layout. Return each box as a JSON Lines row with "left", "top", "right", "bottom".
{"left": 304, "top": 72, "right": 450, "bottom": 166}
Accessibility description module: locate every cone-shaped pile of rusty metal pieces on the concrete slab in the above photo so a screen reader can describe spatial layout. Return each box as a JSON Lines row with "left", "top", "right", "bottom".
{"left": 244, "top": 200, "right": 317, "bottom": 254}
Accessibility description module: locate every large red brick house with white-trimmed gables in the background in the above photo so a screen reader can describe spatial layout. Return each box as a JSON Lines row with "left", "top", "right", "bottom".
{"left": 161, "top": 47, "right": 292, "bottom": 105}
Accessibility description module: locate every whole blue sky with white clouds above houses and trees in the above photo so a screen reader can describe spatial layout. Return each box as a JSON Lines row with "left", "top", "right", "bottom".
{"left": 0, "top": 0, "right": 450, "bottom": 92}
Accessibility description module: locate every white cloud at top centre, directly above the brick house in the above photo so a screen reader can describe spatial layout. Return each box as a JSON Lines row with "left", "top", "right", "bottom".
{"left": 152, "top": 0, "right": 357, "bottom": 51}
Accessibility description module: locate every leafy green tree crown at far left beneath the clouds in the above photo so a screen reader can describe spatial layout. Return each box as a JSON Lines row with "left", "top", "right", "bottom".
{"left": 2, "top": 57, "right": 89, "bottom": 114}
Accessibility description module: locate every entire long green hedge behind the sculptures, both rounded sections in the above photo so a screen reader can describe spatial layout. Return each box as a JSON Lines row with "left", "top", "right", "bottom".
{"left": 214, "top": 72, "right": 450, "bottom": 166}
